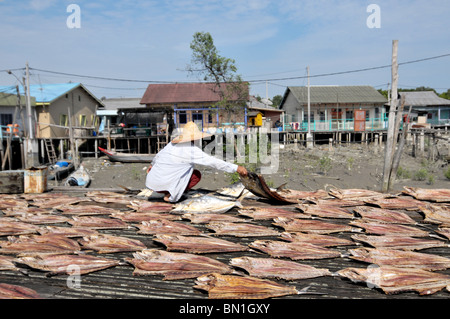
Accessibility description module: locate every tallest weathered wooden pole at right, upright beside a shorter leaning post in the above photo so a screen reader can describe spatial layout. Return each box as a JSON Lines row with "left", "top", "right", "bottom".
{"left": 381, "top": 40, "right": 398, "bottom": 192}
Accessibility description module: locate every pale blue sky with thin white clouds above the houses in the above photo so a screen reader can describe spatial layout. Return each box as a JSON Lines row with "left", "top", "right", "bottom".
{"left": 0, "top": 0, "right": 450, "bottom": 102}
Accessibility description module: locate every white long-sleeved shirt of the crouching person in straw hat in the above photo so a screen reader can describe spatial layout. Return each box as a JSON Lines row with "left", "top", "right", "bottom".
{"left": 145, "top": 143, "right": 238, "bottom": 202}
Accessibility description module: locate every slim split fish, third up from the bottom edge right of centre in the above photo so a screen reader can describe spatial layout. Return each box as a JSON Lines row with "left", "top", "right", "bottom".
{"left": 249, "top": 240, "right": 341, "bottom": 260}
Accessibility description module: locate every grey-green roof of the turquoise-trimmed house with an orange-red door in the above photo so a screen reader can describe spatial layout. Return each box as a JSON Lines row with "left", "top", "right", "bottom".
{"left": 285, "top": 86, "right": 387, "bottom": 104}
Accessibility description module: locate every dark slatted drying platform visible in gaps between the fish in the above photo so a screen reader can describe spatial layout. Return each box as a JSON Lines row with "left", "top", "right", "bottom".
{"left": 0, "top": 193, "right": 450, "bottom": 300}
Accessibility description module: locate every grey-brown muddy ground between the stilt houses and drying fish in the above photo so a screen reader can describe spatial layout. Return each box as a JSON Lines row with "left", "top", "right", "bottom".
{"left": 75, "top": 144, "right": 450, "bottom": 196}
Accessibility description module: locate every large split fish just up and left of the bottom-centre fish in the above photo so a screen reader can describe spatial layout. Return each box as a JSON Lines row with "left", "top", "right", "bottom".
{"left": 125, "top": 249, "right": 233, "bottom": 280}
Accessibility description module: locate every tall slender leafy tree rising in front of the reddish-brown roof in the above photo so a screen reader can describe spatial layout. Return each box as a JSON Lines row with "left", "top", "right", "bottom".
{"left": 187, "top": 32, "right": 248, "bottom": 118}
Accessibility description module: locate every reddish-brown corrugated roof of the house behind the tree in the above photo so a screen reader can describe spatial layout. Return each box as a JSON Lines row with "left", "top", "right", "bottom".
{"left": 141, "top": 83, "right": 248, "bottom": 104}
